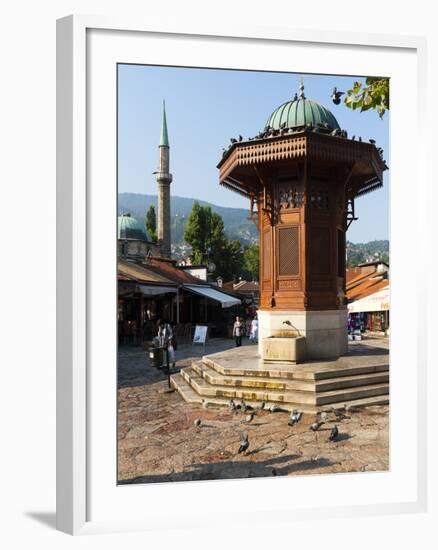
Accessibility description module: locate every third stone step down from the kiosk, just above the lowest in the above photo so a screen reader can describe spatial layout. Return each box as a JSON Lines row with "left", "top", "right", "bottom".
{"left": 181, "top": 367, "right": 389, "bottom": 405}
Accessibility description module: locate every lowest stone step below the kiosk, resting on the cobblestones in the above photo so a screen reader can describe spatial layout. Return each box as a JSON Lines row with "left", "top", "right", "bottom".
{"left": 170, "top": 374, "right": 389, "bottom": 414}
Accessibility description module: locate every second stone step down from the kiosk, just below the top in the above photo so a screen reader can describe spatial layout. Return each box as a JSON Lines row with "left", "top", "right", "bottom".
{"left": 192, "top": 361, "right": 389, "bottom": 392}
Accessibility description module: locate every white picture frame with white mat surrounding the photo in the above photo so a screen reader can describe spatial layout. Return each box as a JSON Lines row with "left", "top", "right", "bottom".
{"left": 57, "top": 16, "right": 427, "bottom": 534}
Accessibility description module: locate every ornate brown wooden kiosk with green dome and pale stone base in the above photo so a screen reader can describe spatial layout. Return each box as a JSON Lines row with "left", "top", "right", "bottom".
{"left": 218, "top": 83, "right": 387, "bottom": 359}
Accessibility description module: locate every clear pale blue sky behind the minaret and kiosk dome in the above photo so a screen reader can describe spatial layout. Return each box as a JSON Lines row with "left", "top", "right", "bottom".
{"left": 118, "top": 65, "right": 390, "bottom": 242}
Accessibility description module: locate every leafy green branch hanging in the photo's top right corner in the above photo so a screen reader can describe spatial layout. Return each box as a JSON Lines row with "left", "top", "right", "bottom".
{"left": 344, "top": 77, "right": 389, "bottom": 118}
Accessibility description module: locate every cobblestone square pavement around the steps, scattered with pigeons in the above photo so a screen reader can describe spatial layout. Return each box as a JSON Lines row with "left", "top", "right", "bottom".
{"left": 118, "top": 338, "right": 389, "bottom": 483}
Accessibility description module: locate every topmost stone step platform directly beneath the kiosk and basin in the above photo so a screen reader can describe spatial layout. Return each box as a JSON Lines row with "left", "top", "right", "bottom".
{"left": 202, "top": 354, "right": 389, "bottom": 380}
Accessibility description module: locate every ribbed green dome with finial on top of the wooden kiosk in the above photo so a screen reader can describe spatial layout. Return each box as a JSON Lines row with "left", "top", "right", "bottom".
{"left": 265, "top": 82, "right": 340, "bottom": 130}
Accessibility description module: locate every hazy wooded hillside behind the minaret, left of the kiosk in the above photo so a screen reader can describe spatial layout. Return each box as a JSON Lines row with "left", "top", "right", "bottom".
{"left": 118, "top": 193, "right": 258, "bottom": 244}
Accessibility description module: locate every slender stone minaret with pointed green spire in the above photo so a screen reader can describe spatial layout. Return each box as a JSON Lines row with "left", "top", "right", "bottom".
{"left": 154, "top": 101, "right": 172, "bottom": 258}
